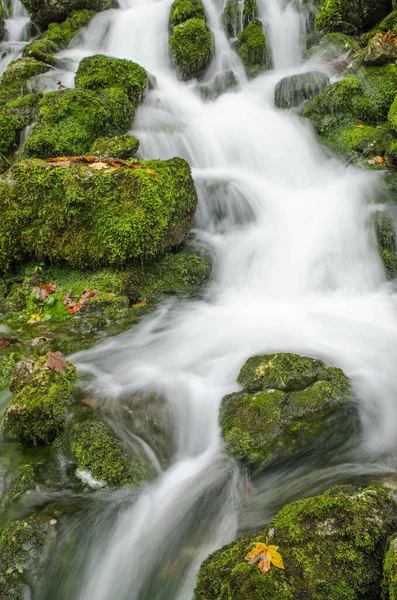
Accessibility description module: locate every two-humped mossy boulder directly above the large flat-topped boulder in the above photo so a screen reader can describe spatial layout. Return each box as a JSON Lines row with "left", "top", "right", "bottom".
{"left": 24, "top": 55, "right": 147, "bottom": 158}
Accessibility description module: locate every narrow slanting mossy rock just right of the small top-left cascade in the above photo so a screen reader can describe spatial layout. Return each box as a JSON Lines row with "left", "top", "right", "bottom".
{"left": 22, "top": 10, "right": 95, "bottom": 65}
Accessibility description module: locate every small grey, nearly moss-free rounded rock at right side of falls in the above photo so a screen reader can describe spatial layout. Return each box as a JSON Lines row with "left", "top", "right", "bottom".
{"left": 274, "top": 71, "right": 329, "bottom": 108}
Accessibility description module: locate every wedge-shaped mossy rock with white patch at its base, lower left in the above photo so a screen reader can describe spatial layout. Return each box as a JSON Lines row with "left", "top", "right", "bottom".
{"left": 69, "top": 407, "right": 149, "bottom": 488}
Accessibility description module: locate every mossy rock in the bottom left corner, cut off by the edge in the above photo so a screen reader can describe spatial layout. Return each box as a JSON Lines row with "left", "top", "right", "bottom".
{"left": 0, "top": 514, "right": 57, "bottom": 600}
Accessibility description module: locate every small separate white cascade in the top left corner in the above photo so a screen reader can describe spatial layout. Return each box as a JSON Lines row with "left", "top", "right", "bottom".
{"left": 0, "top": 0, "right": 30, "bottom": 75}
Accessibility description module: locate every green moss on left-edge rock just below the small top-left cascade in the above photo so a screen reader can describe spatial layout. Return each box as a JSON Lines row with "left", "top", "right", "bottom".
{"left": 0, "top": 58, "right": 48, "bottom": 106}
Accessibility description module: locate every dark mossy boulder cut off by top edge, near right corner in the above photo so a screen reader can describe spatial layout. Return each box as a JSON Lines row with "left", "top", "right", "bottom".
{"left": 316, "top": 0, "right": 392, "bottom": 33}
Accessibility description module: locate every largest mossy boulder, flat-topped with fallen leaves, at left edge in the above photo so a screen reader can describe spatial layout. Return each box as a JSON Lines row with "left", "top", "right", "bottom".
{"left": 0, "top": 158, "right": 197, "bottom": 271}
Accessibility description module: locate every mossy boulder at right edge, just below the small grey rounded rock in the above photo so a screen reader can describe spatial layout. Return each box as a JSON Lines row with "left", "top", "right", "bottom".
{"left": 302, "top": 64, "right": 397, "bottom": 135}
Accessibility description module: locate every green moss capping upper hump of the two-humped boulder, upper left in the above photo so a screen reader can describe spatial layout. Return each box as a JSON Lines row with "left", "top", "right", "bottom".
{"left": 76, "top": 54, "right": 147, "bottom": 109}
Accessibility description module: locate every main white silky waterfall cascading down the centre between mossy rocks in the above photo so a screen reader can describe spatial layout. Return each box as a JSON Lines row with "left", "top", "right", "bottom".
{"left": 48, "top": 0, "right": 397, "bottom": 600}
